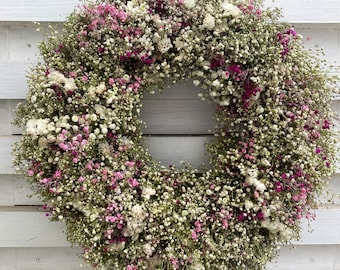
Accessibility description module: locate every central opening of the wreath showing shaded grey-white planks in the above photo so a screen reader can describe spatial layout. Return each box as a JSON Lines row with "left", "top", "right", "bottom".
{"left": 141, "top": 80, "right": 215, "bottom": 167}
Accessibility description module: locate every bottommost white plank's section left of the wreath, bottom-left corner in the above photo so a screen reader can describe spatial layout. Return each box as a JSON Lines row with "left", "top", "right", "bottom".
{"left": 0, "top": 247, "right": 93, "bottom": 270}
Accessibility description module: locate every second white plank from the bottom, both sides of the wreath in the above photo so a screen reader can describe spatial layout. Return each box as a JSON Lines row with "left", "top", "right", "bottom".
{"left": 0, "top": 208, "right": 340, "bottom": 247}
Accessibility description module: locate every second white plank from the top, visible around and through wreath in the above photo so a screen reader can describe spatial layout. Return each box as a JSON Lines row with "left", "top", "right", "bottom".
{"left": 0, "top": 24, "right": 340, "bottom": 99}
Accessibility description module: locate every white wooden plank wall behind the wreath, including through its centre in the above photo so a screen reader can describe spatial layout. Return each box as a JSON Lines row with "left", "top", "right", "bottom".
{"left": 0, "top": 0, "right": 340, "bottom": 270}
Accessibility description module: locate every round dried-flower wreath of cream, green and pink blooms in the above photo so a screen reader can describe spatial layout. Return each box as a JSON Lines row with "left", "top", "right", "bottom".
{"left": 14, "top": 0, "right": 337, "bottom": 270}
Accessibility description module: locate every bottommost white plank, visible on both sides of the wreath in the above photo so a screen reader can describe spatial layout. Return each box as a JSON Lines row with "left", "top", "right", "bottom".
{"left": 0, "top": 245, "right": 340, "bottom": 270}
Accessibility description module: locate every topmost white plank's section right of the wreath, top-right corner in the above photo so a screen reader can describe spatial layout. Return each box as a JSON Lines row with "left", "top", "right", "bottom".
{"left": 265, "top": 0, "right": 340, "bottom": 23}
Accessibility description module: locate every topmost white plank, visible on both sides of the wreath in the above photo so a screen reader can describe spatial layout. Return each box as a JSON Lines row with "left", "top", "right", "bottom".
{"left": 0, "top": 0, "right": 340, "bottom": 23}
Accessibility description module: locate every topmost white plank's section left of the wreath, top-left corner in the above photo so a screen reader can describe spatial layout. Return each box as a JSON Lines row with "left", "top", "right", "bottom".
{"left": 0, "top": 0, "right": 80, "bottom": 22}
